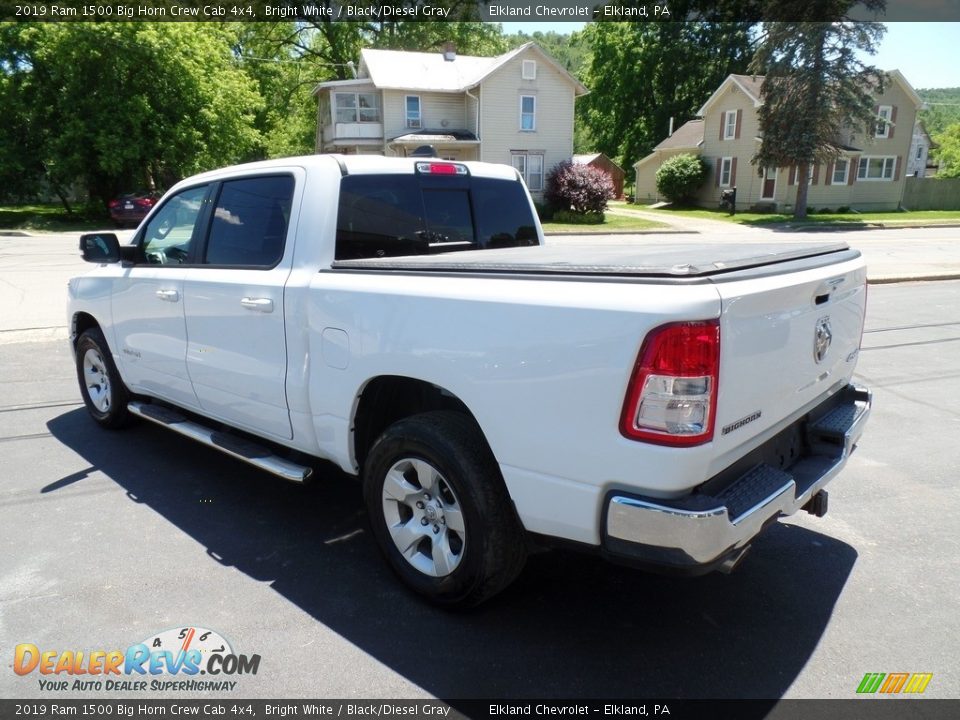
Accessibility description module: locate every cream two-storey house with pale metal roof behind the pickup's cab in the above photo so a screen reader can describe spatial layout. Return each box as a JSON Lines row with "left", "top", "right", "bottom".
{"left": 314, "top": 42, "right": 587, "bottom": 193}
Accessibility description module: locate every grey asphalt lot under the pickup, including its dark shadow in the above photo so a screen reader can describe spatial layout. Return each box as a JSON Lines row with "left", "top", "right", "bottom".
{"left": 0, "top": 232, "right": 960, "bottom": 702}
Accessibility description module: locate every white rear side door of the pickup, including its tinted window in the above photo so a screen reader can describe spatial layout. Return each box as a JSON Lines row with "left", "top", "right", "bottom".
{"left": 183, "top": 170, "right": 301, "bottom": 439}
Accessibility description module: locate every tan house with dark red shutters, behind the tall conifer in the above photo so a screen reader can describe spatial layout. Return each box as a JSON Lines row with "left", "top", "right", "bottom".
{"left": 635, "top": 70, "right": 922, "bottom": 212}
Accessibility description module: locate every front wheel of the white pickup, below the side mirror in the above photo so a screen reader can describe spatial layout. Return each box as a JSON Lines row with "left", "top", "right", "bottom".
{"left": 76, "top": 328, "right": 132, "bottom": 429}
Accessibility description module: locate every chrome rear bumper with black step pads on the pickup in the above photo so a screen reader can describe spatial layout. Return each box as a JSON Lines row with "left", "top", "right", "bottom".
{"left": 601, "top": 385, "right": 872, "bottom": 573}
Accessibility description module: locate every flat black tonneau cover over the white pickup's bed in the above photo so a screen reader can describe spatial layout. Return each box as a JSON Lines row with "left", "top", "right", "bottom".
{"left": 333, "top": 241, "right": 860, "bottom": 278}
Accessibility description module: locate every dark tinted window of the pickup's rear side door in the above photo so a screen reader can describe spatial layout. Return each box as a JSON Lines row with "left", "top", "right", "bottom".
{"left": 203, "top": 175, "right": 294, "bottom": 267}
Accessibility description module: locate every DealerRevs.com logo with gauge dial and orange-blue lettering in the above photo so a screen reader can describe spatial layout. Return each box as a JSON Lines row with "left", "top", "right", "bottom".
{"left": 13, "top": 627, "right": 260, "bottom": 692}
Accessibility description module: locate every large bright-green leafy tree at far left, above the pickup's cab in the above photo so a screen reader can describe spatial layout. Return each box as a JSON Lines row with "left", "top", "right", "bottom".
{"left": 0, "top": 22, "right": 263, "bottom": 211}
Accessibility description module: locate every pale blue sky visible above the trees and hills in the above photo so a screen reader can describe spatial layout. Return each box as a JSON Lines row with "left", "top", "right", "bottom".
{"left": 503, "top": 22, "right": 960, "bottom": 89}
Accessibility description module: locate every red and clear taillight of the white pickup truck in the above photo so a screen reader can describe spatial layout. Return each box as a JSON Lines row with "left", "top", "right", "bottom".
{"left": 620, "top": 320, "right": 720, "bottom": 446}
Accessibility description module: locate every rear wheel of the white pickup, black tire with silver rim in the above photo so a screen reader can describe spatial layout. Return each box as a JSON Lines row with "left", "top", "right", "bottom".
{"left": 363, "top": 411, "right": 526, "bottom": 607}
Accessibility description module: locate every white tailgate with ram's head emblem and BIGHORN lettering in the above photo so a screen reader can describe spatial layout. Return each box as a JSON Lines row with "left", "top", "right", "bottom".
{"left": 713, "top": 253, "right": 867, "bottom": 468}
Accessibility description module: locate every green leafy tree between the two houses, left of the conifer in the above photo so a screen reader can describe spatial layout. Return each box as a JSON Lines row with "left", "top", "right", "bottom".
{"left": 577, "top": 22, "right": 751, "bottom": 181}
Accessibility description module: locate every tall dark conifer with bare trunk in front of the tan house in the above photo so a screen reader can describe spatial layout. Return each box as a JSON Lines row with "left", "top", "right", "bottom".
{"left": 750, "top": 0, "right": 885, "bottom": 218}
